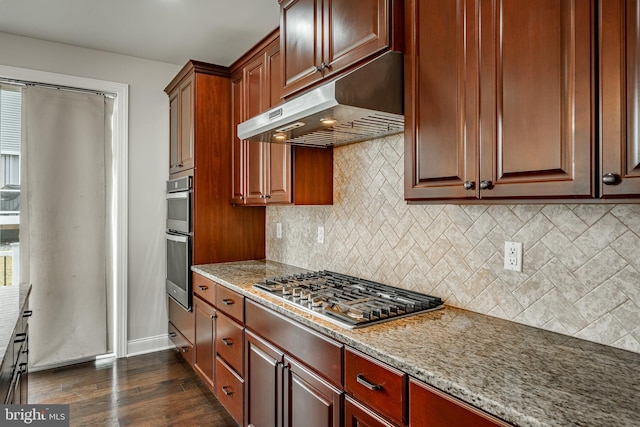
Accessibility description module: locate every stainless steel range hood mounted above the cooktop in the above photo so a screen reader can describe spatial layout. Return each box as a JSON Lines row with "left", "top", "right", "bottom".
{"left": 238, "top": 51, "right": 404, "bottom": 147}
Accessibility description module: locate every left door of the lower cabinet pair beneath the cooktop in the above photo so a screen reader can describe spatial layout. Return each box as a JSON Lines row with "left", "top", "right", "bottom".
{"left": 244, "top": 330, "right": 284, "bottom": 427}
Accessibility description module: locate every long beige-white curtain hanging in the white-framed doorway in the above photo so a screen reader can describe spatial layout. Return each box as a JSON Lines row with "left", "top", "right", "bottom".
{"left": 20, "top": 86, "right": 113, "bottom": 368}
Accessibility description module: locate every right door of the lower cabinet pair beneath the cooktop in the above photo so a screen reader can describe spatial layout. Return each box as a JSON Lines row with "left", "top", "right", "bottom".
{"left": 284, "top": 358, "right": 342, "bottom": 427}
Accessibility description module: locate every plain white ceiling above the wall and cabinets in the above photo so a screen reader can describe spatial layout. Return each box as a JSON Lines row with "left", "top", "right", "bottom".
{"left": 0, "top": 0, "right": 279, "bottom": 66}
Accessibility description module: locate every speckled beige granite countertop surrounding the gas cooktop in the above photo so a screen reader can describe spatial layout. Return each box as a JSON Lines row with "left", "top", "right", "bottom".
{"left": 192, "top": 261, "right": 640, "bottom": 427}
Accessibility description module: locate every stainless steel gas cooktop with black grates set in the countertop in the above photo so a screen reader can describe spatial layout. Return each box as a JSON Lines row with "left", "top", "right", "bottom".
{"left": 253, "top": 270, "right": 444, "bottom": 329}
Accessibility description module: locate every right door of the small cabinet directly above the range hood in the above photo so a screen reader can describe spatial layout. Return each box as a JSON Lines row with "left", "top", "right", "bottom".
{"left": 322, "top": 0, "right": 393, "bottom": 77}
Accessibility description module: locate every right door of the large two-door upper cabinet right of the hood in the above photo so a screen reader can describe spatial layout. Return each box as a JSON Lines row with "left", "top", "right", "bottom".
{"left": 479, "top": 0, "right": 595, "bottom": 199}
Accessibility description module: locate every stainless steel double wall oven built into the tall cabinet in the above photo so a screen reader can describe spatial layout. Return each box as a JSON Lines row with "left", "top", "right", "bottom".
{"left": 165, "top": 176, "right": 192, "bottom": 310}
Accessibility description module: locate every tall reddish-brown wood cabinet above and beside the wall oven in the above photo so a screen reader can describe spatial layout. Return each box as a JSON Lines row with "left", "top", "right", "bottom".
{"left": 165, "top": 61, "right": 265, "bottom": 264}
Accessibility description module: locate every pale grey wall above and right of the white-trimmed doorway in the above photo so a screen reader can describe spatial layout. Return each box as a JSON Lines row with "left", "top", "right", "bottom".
{"left": 0, "top": 33, "right": 183, "bottom": 351}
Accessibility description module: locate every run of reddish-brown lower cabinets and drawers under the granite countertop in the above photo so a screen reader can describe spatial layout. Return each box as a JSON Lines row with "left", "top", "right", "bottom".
{"left": 176, "top": 278, "right": 510, "bottom": 427}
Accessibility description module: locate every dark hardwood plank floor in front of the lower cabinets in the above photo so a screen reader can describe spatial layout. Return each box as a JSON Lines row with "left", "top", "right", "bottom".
{"left": 29, "top": 350, "right": 237, "bottom": 427}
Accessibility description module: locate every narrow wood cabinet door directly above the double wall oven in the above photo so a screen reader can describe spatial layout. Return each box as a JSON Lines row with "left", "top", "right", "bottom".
{"left": 168, "top": 75, "right": 195, "bottom": 174}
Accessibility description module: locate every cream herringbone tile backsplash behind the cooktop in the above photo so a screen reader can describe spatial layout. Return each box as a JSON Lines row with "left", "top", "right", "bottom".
{"left": 267, "top": 135, "right": 640, "bottom": 353}
